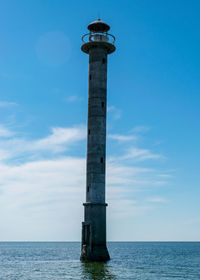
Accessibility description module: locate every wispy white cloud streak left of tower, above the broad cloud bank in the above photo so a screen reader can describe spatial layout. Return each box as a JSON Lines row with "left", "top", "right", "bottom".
{"left": 0, "top": 126, "right": 86, "bottom": 160}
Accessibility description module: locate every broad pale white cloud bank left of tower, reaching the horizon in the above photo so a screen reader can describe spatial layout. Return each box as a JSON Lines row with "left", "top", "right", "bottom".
{"left": 0, "top": 157, "right": 85, "bottom": 240}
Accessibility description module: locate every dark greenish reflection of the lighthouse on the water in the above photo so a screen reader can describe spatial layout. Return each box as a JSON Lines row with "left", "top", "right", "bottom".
{"left": 82, "top": 262, "right": 117, "bottom": 280}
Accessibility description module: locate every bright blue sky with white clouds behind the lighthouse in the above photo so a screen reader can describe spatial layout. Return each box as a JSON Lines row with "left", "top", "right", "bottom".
{"left": 0, "top": 0, "right": 200, "bottom": 241}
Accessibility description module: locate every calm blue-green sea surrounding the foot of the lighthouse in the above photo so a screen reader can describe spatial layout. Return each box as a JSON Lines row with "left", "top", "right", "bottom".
{"left": 0, "top": 242, "right": 200, "bottom": 280}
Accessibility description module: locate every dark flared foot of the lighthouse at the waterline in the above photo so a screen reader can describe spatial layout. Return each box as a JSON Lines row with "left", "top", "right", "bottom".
{"left": 80, "top": 244, "right": 110, "bottom": 262}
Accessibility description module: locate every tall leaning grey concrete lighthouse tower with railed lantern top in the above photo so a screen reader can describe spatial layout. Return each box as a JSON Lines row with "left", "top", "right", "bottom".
{"left": 81, "top": 19, "right": 115, "bottom": 261}
